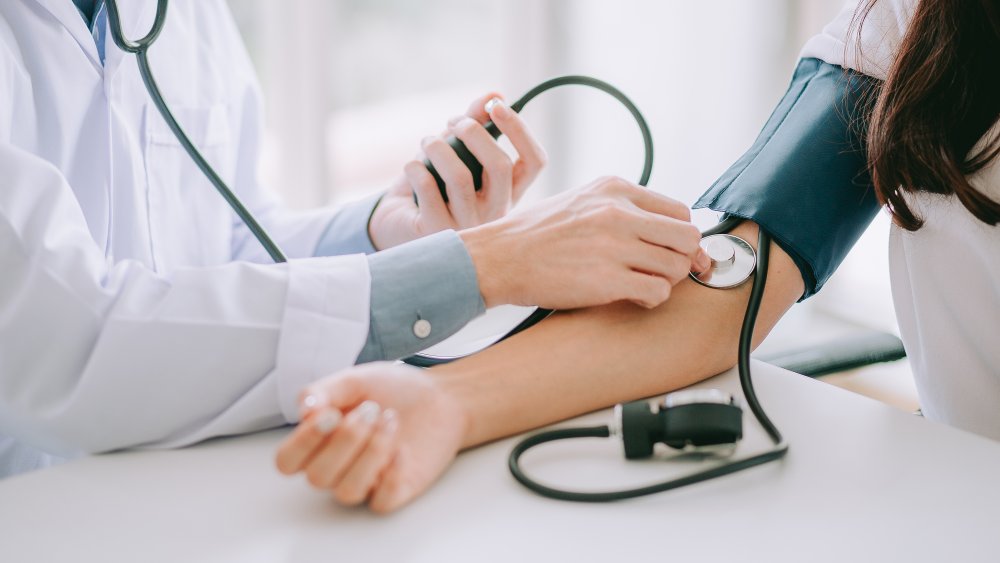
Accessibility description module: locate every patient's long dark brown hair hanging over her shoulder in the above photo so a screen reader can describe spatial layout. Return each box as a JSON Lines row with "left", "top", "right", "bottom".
{"left": 856, "top": 0, "right": 1000, "bottom": 231}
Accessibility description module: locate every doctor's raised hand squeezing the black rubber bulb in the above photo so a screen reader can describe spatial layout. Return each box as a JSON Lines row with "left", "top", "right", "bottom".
{"left": 368, "top": 93, "right": 547, "bottom": 250}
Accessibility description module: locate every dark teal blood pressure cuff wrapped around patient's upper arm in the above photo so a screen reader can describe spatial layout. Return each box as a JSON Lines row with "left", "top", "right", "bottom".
{"left": 694, "top": 59, "right": 879, "bottom": 301}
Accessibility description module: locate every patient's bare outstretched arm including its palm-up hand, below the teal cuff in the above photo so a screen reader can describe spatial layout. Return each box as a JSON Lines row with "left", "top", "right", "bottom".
{"left": 277, "top": 224, "right": 803, "bottom": 512}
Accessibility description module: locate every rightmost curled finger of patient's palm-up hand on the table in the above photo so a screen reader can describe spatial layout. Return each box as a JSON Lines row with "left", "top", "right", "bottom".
{"left": 331, "top": 409, "right": 399, "bottom": 506}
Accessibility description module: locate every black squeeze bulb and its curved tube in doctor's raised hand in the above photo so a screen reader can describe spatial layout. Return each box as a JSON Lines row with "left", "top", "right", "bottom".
{"left": 418, "top": 75, "right": 653, "bottom": 203}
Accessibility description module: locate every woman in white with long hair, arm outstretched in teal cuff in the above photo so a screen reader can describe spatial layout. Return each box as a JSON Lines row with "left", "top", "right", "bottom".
{"left": 277, "top": 0, "right": 1000, "bottom": 512}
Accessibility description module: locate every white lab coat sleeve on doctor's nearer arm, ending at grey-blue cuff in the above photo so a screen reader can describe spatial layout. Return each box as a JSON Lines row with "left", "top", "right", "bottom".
{"left": 0, "top": 142, "right": 370, "bottom": 455}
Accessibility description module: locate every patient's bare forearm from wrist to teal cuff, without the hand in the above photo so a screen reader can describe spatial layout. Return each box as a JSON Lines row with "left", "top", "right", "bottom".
{"left": 433, "top": 223, "right": 803, "bottom": 447}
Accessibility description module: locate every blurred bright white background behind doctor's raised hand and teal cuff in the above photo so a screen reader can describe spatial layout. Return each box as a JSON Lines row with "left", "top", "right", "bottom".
{"left": 230, "top": 0, "right": 913, "bottom": 408}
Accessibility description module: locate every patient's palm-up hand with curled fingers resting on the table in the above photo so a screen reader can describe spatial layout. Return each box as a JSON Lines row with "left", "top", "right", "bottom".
{"left": 277, "top": 363, "right": 467, "bottom": 513}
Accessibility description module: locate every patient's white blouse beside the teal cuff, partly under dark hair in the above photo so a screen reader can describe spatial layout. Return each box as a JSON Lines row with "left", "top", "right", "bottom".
{"left": 802, "top": 0, "right": 1000, "bottom": 440}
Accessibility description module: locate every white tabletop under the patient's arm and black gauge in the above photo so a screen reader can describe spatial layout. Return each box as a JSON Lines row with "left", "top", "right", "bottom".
{"left": 0, "top": 363, "right": 1000, "bottom": 563}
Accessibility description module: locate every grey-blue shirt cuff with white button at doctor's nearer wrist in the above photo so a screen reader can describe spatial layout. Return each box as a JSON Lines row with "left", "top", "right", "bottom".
{"left": 357, "top": 231, "right": 486, "bottom": 364}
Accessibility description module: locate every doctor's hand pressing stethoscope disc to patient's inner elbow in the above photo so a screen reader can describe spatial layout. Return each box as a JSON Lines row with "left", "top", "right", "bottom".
{"left": 459, "top": 178, "right": 711, "bottom": 309}
